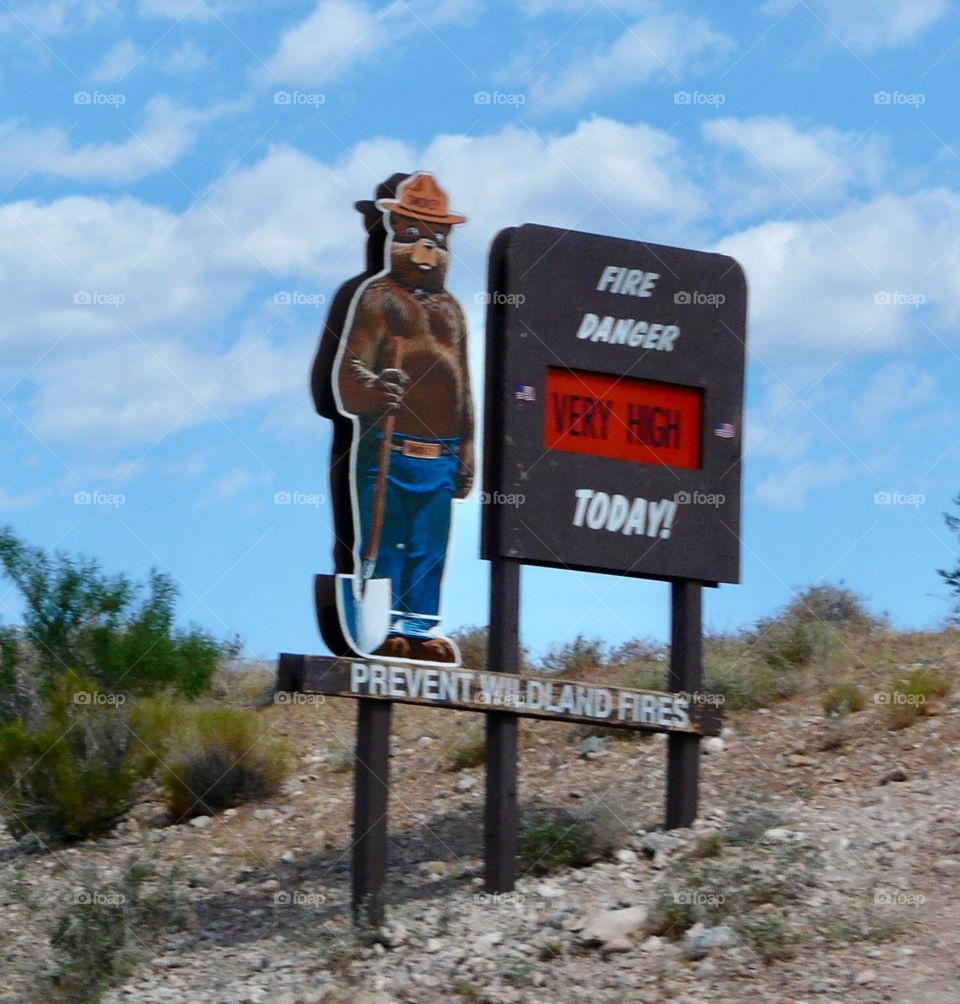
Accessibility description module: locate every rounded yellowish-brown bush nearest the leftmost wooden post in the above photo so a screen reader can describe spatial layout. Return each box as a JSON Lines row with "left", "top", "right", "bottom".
{"left": 160, "top": 705, "right": 289, "bottom": 820}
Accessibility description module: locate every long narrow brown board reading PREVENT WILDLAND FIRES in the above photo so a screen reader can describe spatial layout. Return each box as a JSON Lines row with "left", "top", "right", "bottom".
{"left": 278, "top": 655, "right": 722, "bottom": 736}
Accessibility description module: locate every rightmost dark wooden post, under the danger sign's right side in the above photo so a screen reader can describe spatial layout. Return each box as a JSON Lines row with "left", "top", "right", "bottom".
{"left": 666, "top": 579, "right": 703, "bottom": 829}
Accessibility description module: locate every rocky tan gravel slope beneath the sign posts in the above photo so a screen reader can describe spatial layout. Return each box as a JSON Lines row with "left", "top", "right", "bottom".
{"left": 0, "top": 636, "right": 960, "bottom": 1004}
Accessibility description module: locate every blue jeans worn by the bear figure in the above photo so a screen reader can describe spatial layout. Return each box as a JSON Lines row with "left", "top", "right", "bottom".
{"left": 355, "top": 429, "right": 461, "bottom": 638}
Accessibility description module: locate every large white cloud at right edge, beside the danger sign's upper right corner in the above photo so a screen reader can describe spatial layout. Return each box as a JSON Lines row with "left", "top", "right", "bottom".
{"left": 718, "top": 189, "right": 960, "bottom": 359}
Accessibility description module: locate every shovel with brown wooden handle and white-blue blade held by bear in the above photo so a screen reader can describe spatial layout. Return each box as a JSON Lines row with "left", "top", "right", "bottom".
{"left": 336, "top": 338, "right": 404, "bottom": 656}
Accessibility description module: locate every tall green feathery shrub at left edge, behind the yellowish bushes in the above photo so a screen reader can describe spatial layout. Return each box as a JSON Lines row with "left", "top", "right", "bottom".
{"left": 0, "top": 528, "right": 221, "bottom": 706}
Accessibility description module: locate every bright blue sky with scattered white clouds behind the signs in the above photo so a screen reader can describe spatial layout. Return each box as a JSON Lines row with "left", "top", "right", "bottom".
{"left": 0, "top": 0, "right": 960, "bottom": 658}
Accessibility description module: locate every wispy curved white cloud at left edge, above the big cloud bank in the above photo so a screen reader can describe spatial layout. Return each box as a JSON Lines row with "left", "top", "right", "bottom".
{"left": 0, "top": 95, "right": 219, "bottom": 184}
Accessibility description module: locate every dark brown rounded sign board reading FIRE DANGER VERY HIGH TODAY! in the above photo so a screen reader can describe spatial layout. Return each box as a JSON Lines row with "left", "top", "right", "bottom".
{"left": 483, "top": 225, "right": 746, "bottom": 583}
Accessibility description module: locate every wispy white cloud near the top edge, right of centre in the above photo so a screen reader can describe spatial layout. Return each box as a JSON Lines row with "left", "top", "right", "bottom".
{"left": 514, "top": 11, "right": 732, "bottom": 109}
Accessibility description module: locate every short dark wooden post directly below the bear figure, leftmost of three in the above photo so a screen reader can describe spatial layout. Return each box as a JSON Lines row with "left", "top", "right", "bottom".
{"left": 352, "top": 700, "right": 392, "bottom": 928}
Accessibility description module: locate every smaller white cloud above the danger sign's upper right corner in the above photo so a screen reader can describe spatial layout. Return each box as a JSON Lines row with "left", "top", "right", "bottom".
{"left": 702, "top": 115, "right": 885, "bottom": 215}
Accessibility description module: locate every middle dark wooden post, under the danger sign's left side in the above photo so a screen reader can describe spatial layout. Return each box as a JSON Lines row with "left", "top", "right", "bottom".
{"left": 483, "top": 557, "right": 520, "bottom": 893}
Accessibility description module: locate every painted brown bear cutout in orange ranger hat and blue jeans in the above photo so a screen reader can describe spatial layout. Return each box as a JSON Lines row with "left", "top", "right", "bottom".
{"left": 333, "top": 173, "right": 475, "bottom": 663}
